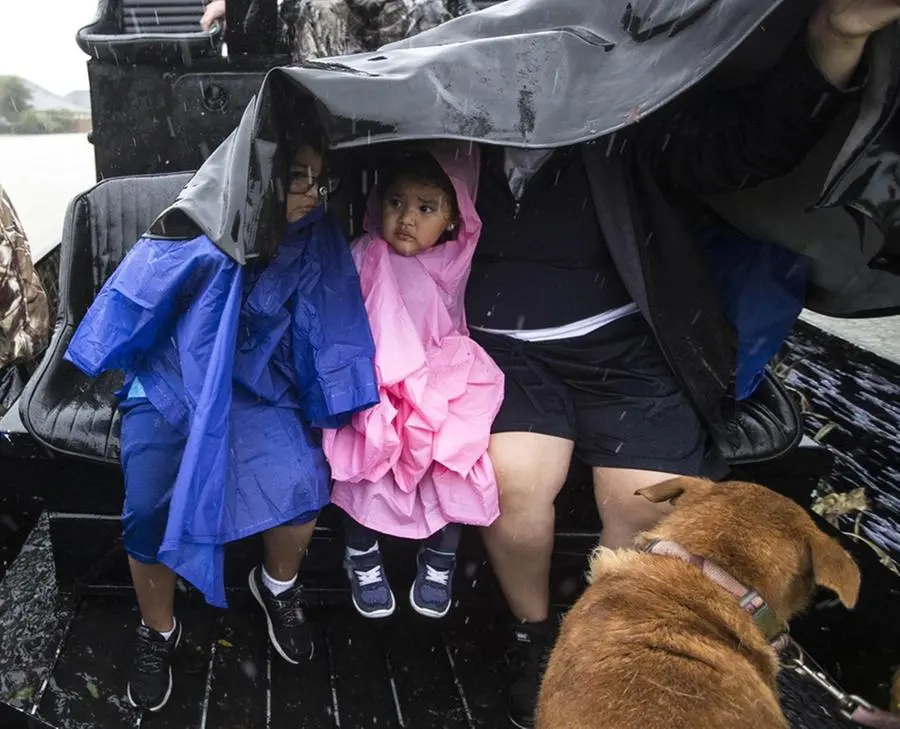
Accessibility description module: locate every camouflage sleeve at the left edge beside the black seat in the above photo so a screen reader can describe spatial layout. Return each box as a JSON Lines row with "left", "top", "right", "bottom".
{"left": 0, "top": 186, "right": 50, "bottom": 369}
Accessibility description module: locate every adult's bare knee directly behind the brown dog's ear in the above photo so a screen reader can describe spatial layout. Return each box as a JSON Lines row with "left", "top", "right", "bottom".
{"left": 594, "top": 468, "right": 678, "bottom": 549}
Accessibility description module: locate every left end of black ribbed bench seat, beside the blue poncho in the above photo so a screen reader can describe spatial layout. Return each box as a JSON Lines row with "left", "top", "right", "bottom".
{"left": 19, "top": 172, "right": 193, "bottom": 463}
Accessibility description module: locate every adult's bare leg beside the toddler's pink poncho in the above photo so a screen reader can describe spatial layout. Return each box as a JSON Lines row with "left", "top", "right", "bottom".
{"left": 483, "top": 433, "right": 573, "bottom": 623}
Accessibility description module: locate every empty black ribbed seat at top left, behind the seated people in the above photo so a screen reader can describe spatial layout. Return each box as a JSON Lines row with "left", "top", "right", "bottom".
{"left": 75, "top": 0, "right": 222, "bottom": 66}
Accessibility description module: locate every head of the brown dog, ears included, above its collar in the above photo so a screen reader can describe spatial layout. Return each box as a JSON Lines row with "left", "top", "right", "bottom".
{"left": 636, "top": 478, "right": 860, "bottom": 620}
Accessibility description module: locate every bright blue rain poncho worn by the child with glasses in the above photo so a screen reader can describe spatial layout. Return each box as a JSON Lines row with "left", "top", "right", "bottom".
{"left": 66, "top": 206, "right": 378, "bottom": 606}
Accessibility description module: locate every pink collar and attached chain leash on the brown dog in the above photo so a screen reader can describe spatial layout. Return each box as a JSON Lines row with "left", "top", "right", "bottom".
{"left": 643, "top": 539, "right": 900, "bottom": 729}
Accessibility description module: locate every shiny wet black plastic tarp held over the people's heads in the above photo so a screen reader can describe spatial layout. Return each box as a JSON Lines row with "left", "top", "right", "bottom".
{"left": 153, "top": 0, "right": 900, "bottom": 310}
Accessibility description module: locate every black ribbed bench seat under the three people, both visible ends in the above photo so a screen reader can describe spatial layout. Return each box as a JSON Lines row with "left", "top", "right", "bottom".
{"left": 20, "top": 173, "right": 802, "bottom": 465}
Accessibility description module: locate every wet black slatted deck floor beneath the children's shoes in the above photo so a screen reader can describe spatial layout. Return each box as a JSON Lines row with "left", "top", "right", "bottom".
{"left": 12, "top": 598, "right": 504, "bottom": 729}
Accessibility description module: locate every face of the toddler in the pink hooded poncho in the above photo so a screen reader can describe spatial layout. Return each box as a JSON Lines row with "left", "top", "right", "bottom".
{"left": 381, "top": 177, "right": 455, "bottom": 256}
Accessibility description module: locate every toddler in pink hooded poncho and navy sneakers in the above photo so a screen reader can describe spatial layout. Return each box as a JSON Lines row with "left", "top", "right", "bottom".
{"left": 324, "top": 144, "right": 503, "bottom": 618}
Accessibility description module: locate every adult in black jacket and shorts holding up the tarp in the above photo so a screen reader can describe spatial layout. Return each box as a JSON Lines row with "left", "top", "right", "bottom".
{"left": 466, "top": 0, "right": 900, "bottom": 727}
